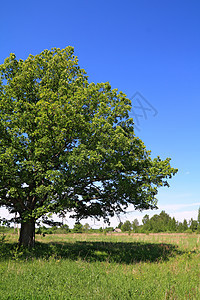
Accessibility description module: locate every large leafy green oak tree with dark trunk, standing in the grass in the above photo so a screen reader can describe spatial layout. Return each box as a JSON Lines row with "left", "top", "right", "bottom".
{"left": 0, "top": 47, "right": 177, "bottom": 246}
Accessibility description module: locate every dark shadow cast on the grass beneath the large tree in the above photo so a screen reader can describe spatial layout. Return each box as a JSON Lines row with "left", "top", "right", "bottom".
{"left": 0, "top": 241, "right": 183, "bottom": 264}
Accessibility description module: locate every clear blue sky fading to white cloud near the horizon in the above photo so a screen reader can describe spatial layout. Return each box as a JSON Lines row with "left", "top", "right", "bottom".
{"left": 0, "top": 0, "right": 200, "bottom": 225}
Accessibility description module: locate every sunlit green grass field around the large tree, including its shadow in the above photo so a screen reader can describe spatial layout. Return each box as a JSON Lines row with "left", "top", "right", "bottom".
{"left": 0, "top": 234, "right": 200, "bottom": 300}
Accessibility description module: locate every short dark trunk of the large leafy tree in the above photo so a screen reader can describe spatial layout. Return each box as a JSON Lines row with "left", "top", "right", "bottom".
{"left": 19, "top": 219, "right": 35, "bottom": 248}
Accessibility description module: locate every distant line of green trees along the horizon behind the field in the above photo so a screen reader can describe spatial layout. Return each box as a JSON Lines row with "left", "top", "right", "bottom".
{"left": 0, "top": 208, "right": 200, "bottom": 235}
